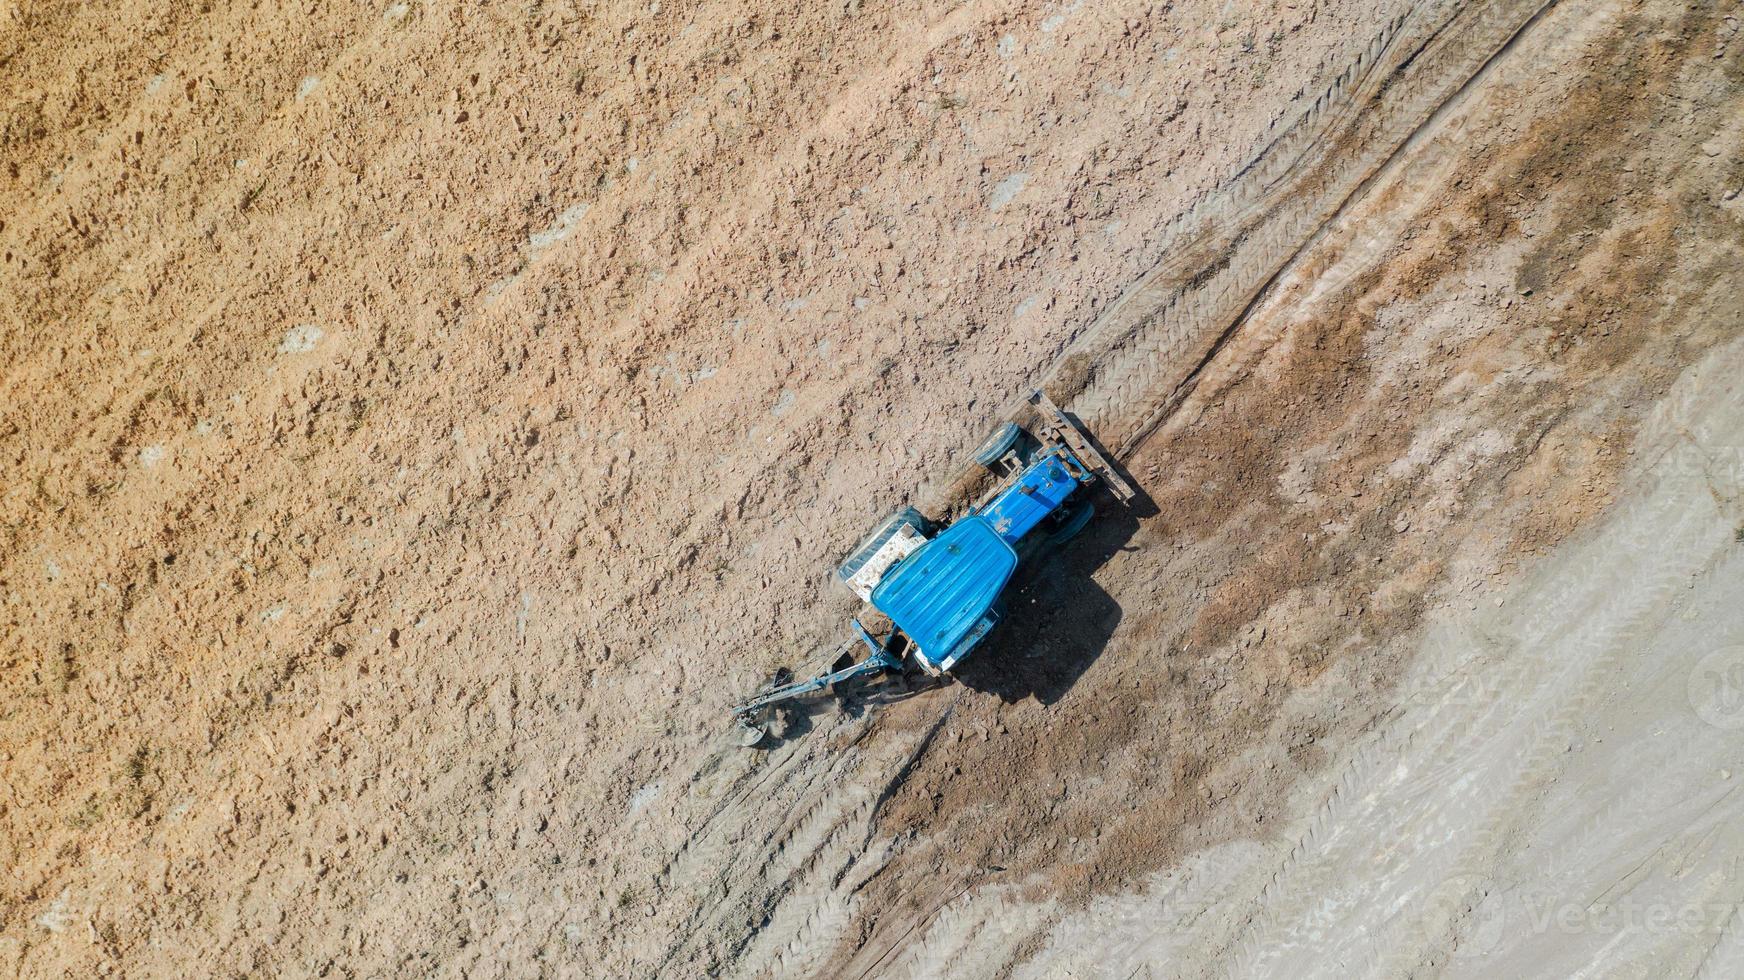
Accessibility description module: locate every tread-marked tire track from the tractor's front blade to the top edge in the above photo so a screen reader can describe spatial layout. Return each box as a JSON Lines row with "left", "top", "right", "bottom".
{"left": 1043, "top": 0, "right": 1554, "bottom": 457}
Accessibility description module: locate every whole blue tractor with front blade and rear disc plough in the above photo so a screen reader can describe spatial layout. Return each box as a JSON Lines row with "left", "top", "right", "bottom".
{"left": 734, "top": 391, "right": 1134, "bottom": 746}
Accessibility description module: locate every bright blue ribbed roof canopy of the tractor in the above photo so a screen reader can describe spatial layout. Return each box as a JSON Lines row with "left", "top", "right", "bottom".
{"left": 872, "top": 516, "right": 1017, "bottom": 666}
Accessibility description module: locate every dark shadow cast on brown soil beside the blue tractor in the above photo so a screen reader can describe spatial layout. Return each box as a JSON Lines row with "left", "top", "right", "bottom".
{"left": 956, "top": 471, "right": 1156, "bottom": 704}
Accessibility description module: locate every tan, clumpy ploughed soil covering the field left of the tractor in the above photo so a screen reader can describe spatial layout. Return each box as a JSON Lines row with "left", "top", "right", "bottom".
{"left": 10, "top": 0, "right": 1416, "bottom": 975}
